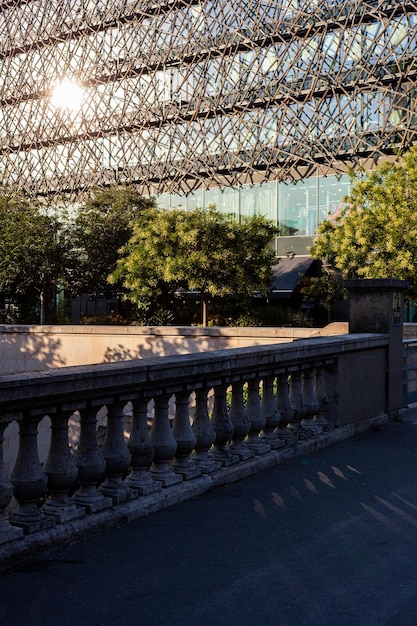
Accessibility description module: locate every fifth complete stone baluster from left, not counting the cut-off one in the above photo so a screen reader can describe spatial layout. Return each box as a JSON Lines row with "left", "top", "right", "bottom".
{"left": 125, "top": 398, "right": 161, "bottom": 496}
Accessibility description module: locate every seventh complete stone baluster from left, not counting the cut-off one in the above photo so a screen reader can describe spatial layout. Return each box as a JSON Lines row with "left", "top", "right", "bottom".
{"left": 172, "top": 391, "right": 201, "bottom": 480}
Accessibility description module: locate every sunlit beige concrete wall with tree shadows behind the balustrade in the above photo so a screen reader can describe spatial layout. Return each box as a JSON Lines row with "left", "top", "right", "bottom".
{"left": 0, "top": 324, "right": 348, "bottom": 376}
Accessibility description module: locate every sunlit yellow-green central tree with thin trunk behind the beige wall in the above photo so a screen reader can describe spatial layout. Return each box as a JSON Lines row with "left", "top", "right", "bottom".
{"left": 111, "top": 207, "right": 277, "bottom": 326}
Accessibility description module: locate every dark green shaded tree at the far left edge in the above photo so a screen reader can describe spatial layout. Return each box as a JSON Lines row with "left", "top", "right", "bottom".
{"left": 0, "top": 190, "right": 68, "bottom": 324}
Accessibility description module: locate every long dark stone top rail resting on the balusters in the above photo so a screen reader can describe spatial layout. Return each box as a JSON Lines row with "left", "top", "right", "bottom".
{"left": 0, "top": 334, "right": 388, "bottom": 422}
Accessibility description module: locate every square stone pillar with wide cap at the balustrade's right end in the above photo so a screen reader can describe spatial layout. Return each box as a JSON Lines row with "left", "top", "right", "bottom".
{"left": 344, "top": 278, "right": 409, "bottom": 419}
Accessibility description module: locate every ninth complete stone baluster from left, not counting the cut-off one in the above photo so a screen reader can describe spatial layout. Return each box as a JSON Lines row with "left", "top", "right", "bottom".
{"left": 209, "top": 384, "right": 239, "bottom": 466}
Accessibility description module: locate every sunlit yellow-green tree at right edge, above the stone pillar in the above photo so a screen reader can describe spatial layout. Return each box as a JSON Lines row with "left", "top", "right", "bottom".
{"left": 311, "top": 147, "right": 417, "bottom": 294}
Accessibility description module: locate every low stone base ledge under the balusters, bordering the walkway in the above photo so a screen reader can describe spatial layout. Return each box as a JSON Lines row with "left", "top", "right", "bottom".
{"left": 0, "top": 414, "right": 389, "bottom": 570}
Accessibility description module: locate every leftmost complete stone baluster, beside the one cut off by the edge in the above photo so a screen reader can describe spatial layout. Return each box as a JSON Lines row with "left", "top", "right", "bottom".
{"left": 9, "top": 412, "right": 55, "bottom": 534}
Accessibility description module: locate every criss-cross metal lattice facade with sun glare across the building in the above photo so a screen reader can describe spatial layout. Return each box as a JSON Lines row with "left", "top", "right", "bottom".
{"left": 0, "top": 0, "right": 417, "bottom": 200}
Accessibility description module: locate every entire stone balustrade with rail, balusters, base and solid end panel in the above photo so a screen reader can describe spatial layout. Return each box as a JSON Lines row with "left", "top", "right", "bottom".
{"left": 0, "top": 334, "right": 389, "bottom": 561}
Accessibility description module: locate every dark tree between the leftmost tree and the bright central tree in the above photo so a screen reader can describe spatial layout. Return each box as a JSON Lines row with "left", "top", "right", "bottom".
{"left": 70, "top": 186, "right": 155, "bottom": 297}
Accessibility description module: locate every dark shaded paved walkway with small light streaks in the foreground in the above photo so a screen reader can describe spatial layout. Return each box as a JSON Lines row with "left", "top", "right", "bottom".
{"left": 0, "top": 409, "right": 417, "bottom": 626}
